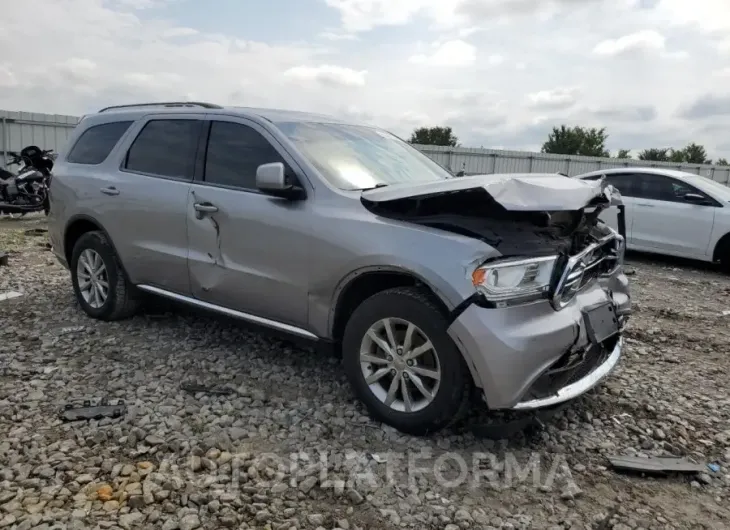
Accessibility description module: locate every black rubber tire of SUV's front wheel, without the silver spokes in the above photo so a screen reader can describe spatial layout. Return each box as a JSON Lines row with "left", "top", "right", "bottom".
{"left": 342, "top": 287, "right": 473, "bottom": 436}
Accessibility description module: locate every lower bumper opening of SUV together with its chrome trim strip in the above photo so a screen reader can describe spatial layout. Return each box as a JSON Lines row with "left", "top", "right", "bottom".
{"left": 514, "top": 335, "right": 623, "bottom": 410}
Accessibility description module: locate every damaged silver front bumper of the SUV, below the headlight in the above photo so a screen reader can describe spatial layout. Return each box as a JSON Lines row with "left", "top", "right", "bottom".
{"left": 448, "top": 273, "right": 631, "bottom": 410}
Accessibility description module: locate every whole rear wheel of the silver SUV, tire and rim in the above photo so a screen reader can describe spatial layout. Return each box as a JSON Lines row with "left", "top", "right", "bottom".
{"left": 70, "top": 231, "right": 139, "bottom": 320}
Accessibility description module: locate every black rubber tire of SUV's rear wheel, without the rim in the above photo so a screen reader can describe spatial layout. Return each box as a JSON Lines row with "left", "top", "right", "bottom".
{"left": 70, "top": 231, "right": 139, "bottom": 321}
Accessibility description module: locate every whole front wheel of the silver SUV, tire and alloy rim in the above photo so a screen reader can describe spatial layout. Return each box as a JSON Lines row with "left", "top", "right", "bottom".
{"left": 342, "top": 287, "right": 473, "bottom": 435}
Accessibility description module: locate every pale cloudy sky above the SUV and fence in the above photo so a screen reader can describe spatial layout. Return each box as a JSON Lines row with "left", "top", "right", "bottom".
{"left": 0, "top": 0, "right": 730, "bottom": 158}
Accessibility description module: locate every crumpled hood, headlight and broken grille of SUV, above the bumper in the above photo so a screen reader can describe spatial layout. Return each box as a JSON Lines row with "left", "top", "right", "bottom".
{"left": 362, "top": 174, "right": 625, "bottom": 309}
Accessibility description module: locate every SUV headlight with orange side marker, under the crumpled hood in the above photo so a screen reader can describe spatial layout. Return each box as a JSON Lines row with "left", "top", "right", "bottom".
{"left": 471, "top": 256, "right": 557, "bottom": 307}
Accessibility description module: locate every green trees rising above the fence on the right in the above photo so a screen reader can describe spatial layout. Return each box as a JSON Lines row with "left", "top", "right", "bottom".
{"left": 409, "top": 125, "right": 730, "bottom": 166}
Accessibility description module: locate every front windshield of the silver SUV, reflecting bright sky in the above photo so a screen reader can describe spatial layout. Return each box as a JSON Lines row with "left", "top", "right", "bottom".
{"left": 277, "top": 122, "right": 452, "bottom": 190}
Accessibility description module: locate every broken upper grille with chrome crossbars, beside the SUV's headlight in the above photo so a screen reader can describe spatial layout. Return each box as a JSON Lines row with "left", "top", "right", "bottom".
{"left": 551, "top": 233, "right": 624, "bottom": 309}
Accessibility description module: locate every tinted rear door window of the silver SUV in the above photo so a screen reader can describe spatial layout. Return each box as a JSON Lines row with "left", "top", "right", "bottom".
{"left": 124, "top": 119, "right": 203, "bottom": 180}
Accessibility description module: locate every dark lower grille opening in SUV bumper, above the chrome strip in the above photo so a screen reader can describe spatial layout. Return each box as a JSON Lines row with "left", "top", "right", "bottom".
{"left": 523, "top": 336, "right": 619, "bottom": 401}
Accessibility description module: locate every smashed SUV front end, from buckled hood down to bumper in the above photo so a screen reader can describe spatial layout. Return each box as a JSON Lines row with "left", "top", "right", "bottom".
{"left": 362, "top": 174, "right": 631, "bottom": 410}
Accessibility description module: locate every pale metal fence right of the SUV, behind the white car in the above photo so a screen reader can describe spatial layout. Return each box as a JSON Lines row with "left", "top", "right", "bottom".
{"left": 416, "top": 145, "right": 730, "bottom": 185}
